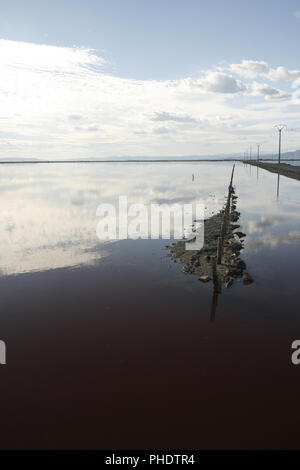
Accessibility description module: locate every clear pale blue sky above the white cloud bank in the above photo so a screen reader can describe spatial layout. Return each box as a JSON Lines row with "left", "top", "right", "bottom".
{"left": 0, "top": 0, "right": 300, "bottom": 79}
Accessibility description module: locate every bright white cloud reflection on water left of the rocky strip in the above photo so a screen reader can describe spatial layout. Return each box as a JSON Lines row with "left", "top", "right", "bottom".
{"left": 0, "top": 164, "right": 230, "bottom": 275}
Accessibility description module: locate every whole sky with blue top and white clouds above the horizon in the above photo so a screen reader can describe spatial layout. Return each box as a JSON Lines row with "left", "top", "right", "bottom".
{"left": 0, "top": 0, "right": 300, "bottom": 160}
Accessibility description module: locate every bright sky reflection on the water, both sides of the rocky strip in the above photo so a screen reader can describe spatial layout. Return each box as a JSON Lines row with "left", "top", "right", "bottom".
{"left": 0, "top": 162, "right": 300, "bottom": 275}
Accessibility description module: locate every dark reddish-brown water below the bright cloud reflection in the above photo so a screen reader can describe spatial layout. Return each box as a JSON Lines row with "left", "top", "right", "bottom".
{"left": 0, "top": 166, "right": 300, "bottom": 449}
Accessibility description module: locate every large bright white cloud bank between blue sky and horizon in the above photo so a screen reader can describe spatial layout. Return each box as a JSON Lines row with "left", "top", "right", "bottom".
{"left": 0, "top": 39, "right": 298, "bottom": 159}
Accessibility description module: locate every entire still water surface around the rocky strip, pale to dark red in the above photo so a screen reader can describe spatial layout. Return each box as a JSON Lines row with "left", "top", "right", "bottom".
{"left": 0, "top": 163, "right": 300, "bottom": 449}
